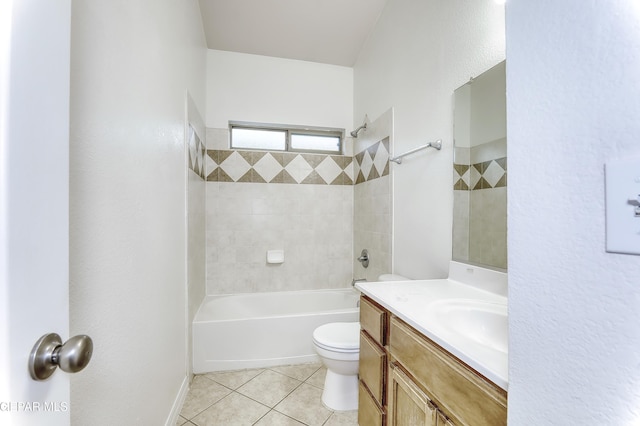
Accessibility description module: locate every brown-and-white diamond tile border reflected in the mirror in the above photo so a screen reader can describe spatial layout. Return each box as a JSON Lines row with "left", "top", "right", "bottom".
{"left": 453, "top": 157, "right": 507, "bottom": 191}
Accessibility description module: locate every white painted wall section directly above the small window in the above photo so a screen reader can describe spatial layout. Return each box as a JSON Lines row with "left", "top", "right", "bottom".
{"left": 206, "top": 50, "right": 353, "bottom": 132}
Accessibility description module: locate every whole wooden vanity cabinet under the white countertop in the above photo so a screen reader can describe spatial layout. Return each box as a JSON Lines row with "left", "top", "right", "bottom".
{"left": 358, "top": 296, "right": 507, "bottom": 426}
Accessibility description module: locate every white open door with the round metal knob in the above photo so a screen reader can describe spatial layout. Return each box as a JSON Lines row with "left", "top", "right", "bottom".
{"left": 0, "top": 0, "right": 72, "bottom": 426}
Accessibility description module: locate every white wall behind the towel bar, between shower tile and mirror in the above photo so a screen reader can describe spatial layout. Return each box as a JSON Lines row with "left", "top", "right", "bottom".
{"left": 354, "top": 0, "right": 505, "bottom": 278}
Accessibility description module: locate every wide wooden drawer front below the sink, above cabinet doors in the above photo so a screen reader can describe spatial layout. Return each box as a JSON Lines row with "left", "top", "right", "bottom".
{"left": 389, "top": 317, "right": 507, "bottom": 426}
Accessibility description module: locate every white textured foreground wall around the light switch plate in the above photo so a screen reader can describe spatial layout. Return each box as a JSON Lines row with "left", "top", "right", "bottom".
{"left": 507, "top": 0, "right": 640, "bottom": 425}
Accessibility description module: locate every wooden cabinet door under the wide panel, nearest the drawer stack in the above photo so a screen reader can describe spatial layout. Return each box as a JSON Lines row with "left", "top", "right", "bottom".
{"left": 387, "top": 365, "right": 438, "bottom": 426}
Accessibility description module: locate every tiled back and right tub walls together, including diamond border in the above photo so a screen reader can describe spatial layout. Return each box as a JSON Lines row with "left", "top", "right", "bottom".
{"left": 204, "top": 120, "right": 392, "bottom": 294}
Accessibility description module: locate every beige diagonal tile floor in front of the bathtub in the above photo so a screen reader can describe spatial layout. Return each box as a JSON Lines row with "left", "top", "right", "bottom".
{"left": 176, "top": 364, "right": 358, "bottom": 426}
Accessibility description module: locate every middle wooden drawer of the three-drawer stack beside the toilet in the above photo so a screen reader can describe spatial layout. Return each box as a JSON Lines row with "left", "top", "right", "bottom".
{"left": 359, "top": 331, "right": 387, "bottom": 405}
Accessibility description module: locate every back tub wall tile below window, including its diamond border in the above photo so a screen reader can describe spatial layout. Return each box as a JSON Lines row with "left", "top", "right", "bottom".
{"left": 205, "top": 129, "right": 354, "bottom": 294}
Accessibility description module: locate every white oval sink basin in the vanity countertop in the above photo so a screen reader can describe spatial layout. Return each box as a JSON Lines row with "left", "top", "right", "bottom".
{"left": 429, "top": 299, "right": 508, "bottom": 354}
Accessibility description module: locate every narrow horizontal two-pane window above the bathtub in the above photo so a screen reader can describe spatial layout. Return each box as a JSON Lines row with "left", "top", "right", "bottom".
{"left": 229, "top": 121, "right": 344, "bottom": 154}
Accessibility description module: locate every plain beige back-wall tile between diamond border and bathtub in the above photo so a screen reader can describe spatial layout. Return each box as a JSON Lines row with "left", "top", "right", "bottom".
{"left": 206, "top": 182, "right": 353, "bottom": 294}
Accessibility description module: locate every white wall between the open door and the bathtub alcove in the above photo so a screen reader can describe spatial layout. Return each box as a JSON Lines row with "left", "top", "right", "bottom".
{"left": 70, "top": 0, "right": 206, "bottom": 425}
